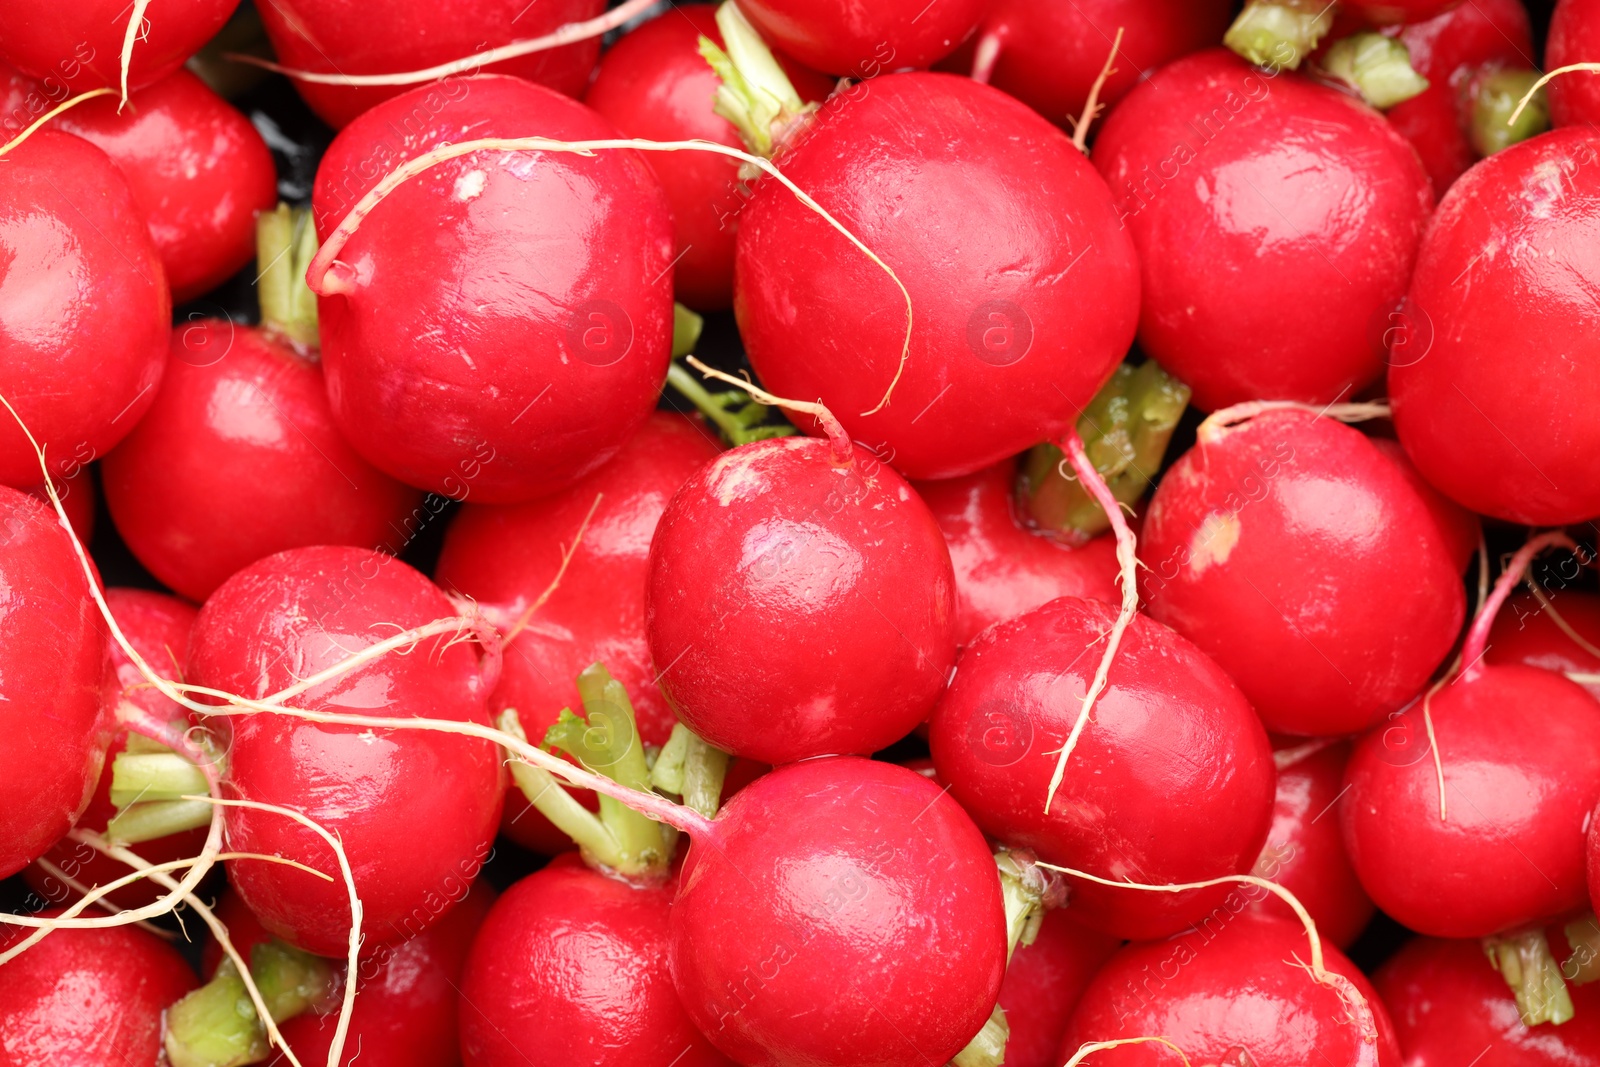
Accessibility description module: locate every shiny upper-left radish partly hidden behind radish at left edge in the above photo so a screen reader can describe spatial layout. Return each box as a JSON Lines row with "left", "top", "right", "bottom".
{"left": 0, "top": 67, "right": 277, "bottom": 304}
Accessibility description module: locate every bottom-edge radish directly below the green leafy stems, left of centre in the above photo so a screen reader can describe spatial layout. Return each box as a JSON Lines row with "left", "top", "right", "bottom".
{"left": 461, "top": 854, "right": 730, "bottom": 1067}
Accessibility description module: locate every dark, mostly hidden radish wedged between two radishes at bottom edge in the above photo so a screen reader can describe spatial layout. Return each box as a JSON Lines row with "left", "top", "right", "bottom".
{"left": 1000, "top": 910, "right": 1120, "bottom": 1067}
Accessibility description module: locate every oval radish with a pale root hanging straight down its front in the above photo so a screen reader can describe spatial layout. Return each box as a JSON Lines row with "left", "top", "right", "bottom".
{"left": 928, "top": 597, "right": 1275, "bottom": 937}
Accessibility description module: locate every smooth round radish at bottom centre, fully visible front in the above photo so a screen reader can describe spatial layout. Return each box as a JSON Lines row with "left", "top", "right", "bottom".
{"left": 672, "top": 757, "right": 1006, "bottom": 1067}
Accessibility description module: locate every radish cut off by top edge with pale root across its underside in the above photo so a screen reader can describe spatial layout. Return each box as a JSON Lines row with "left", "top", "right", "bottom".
{"left": 259, "top": 0, "right": 606, "bottom": 133}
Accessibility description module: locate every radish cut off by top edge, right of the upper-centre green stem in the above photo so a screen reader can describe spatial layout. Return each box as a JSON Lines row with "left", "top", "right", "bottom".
{"left": 739, "top": 0, "right": 989, "bottom": 78}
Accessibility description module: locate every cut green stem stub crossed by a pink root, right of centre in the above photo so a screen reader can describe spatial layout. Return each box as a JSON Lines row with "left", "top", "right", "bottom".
{"left": 1018, "top": 360, "right": 1189, "bottom": 544}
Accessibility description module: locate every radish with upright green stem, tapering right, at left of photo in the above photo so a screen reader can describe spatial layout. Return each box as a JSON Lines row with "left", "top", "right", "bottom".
{"left": 101, "top": 318, "right": 422, "bottom": 600}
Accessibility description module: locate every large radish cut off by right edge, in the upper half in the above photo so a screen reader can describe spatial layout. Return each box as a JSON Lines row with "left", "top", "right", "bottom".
{"left": 1389, "top": 126, "right": 1600, "bottom": 523}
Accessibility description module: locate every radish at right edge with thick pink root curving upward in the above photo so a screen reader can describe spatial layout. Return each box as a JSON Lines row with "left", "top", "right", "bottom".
{"left": 1341, "top": 534, "right": 1600, "bottom": 1017}
